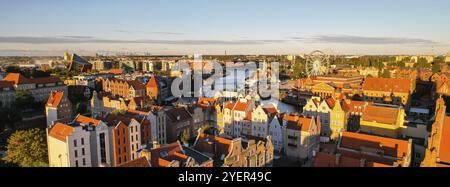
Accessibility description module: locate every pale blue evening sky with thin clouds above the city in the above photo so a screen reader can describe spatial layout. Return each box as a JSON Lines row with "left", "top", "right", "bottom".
{"left": 0, "top": 0, "right": 450, "bottom": 55}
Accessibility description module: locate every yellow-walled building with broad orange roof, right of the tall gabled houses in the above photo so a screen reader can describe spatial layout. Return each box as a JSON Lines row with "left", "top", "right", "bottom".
{"left": 360, "top": 104, "right": 406, "bottom": 138}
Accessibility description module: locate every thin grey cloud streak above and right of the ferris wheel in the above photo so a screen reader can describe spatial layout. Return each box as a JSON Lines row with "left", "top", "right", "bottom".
{"left": 291, "top": 35, "right": 440, "bottom": 45}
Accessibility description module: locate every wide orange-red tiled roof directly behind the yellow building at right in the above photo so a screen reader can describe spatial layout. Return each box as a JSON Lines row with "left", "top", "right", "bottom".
{"left": 363, "top": 77, "right": 411, "bottom": 93}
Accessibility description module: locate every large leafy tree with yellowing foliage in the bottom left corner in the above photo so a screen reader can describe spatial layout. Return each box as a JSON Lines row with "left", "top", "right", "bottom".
{"left": 3, "top": 129, "right": 48, "bottom": 167}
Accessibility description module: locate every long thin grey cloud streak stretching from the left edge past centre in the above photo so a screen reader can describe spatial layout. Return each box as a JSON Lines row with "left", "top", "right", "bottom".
{"left": 0, "top": 36, "right": 287, "bottom": 45}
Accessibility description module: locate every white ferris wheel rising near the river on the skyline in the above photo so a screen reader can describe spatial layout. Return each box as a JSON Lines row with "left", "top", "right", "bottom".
{"left": 306, "top": 50, "right": 330, "bottom": 76}
